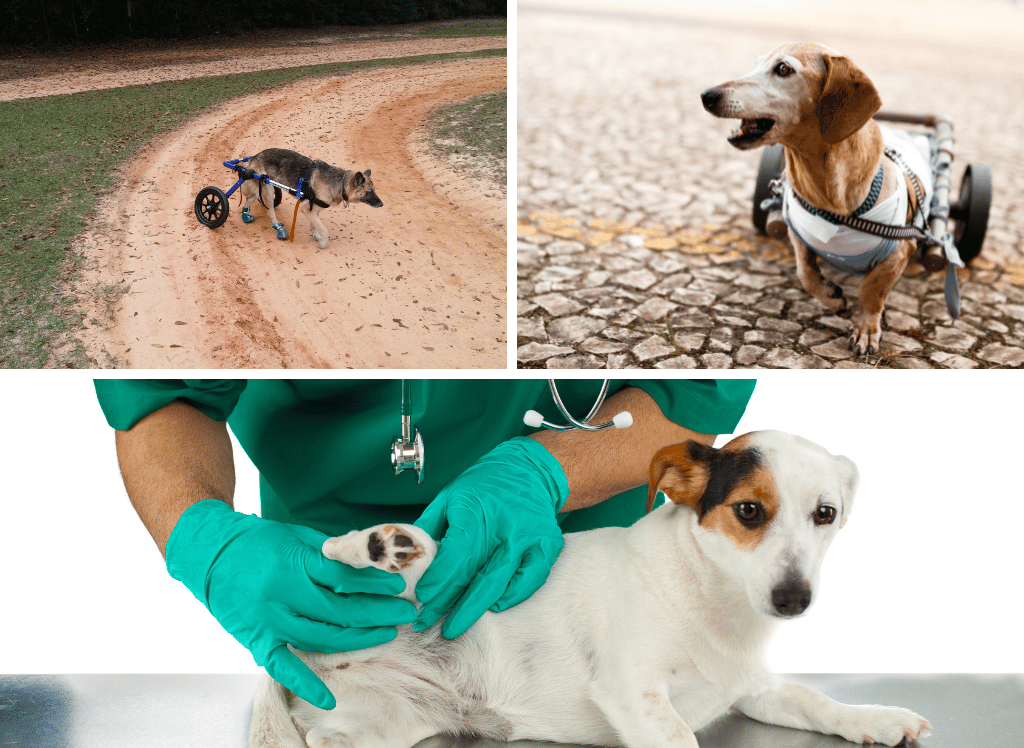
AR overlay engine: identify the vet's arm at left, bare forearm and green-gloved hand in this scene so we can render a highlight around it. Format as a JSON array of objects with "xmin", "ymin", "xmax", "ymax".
[{"xmin": 110, "ymin": 393, "xmax": 416, "ymax": 709}]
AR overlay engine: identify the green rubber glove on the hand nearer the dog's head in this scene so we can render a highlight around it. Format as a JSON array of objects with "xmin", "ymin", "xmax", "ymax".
[{"xmin": 414, "ymin": 437, "xmax": 569, "ymax": 638}]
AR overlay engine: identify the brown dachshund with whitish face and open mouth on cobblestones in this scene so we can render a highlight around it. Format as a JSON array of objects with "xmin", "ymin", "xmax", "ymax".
[{"xmin": 700, "ymin": 43, "xmax": 932, "ymax": 355}]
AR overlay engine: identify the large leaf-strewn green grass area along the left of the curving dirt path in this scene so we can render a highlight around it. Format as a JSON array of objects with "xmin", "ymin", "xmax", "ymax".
[{"xmin": 0, "ymin": 40, "xmax": 506, "ymax": 368}]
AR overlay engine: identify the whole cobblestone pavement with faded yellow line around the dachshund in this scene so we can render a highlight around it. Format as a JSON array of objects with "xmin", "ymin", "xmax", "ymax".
[{"xmin": 517, "ymin": 0, "xmax": 1024, "ymax": 368}]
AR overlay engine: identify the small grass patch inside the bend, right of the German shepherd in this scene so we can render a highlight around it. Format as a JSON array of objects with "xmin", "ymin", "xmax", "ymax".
[{"xmin": 430, "ymin": 90, "xmax": 508, "ymax": 184}]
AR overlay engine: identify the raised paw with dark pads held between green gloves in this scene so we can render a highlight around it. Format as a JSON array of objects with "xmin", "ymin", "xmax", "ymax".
[{"xmin": 324, "ymin": 525, "xmax": 436, "ymax": 573}]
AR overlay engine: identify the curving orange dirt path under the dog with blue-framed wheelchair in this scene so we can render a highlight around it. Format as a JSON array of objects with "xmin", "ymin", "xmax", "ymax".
[{"xmin": 68, "ymin": 58, "xmax": 507, "ymax": 369}]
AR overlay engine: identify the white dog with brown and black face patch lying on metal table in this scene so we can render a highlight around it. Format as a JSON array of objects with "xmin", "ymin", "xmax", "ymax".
[{"xmin": 250, "ymin": 431, "xmax": 931, "ymax": 748}]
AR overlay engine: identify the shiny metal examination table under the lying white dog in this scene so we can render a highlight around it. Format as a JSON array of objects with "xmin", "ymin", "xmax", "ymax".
[{"xmin": 0, "ymin": 675, "xmax": 1024, "ymax": 748}]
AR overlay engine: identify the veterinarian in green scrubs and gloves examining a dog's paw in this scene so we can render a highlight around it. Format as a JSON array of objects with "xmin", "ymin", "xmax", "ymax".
[{"xmin": 95, "ymin": 379, "xmax": 755, "ymax": 709}]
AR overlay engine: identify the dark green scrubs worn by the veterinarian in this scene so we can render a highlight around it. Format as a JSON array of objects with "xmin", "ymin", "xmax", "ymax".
[{"xmin": 95, "ymin": 379, "xmax": 755, "ymax": 535}]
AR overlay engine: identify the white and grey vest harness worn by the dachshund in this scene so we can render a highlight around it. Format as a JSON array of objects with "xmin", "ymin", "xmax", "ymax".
[{"xmin": 774, "ymin": 125, "xmax": 963, "ymax": 319}]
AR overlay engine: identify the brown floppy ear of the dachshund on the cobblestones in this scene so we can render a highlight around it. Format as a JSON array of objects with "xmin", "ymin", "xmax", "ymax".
[{"xmin": 817, "ymin": 53, "xmax": 882, "ymax": 146}]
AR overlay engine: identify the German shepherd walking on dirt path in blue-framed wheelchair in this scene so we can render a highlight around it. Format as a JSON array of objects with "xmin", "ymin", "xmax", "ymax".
[{"xmin": 241, "ymin": 148, "xmax": 384, "ymax": 249}]
